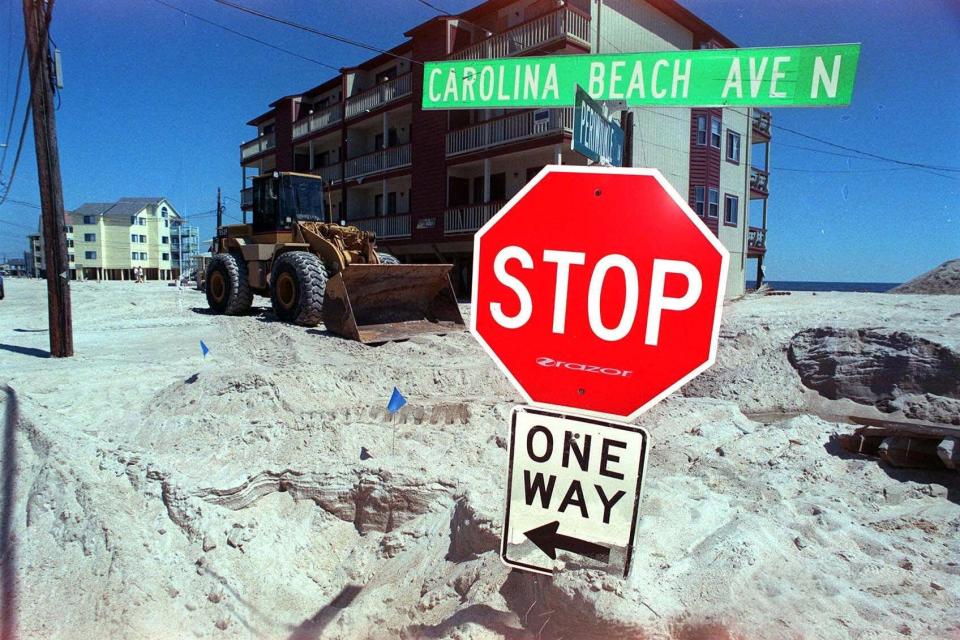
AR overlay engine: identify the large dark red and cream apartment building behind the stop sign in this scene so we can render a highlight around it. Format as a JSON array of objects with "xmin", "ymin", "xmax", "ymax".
[{"xmin": 240, "ymin": 0, "xmax": 770, "ymax": 296}]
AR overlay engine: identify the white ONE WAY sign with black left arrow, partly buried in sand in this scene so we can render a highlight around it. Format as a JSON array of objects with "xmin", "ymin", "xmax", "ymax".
[{"xmin": 500, "ymin": 407, "xmax": 648, "ymax": 577}]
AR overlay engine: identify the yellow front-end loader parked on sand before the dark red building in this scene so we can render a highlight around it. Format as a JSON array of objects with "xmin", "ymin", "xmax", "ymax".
[{"xmin": 206, "ymin": 172, "xmax": 464, "ymax": 344}]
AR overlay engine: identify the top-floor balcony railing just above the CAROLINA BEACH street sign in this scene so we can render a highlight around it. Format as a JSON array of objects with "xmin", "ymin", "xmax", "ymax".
[{"xmin": 450, "ymin": 7, "xmax": 590, "ymax": 60}]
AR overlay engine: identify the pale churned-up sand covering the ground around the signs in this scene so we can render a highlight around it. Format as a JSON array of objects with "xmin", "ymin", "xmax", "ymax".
[{"xmin": 0, "ymin": 279, "xmax": 960, "ymax": 639}]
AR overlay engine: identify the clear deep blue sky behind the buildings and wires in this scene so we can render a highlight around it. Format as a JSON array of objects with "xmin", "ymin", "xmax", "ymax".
[{"xmin": 0, "ymin": 0, "xmax": 960, "ymax": 282}]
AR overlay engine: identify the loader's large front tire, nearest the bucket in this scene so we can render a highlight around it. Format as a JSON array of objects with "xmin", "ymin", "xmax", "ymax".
[{"xmin": 270, "ymin": 251, "xmax": 327, "ymax": 327}]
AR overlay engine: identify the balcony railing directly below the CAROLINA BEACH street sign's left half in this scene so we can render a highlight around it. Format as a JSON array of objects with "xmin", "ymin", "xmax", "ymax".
[{"xmin": 447, "ymin": 109, "xmax": 573, "ymax": 156}]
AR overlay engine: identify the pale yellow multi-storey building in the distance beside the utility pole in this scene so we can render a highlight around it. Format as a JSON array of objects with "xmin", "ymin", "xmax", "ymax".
[{"xmin": 28, "ymin": 197, "xmax": 183, "ymax": 280}]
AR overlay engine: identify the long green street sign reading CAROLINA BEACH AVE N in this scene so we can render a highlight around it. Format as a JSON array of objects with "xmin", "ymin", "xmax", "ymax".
[{"xmin": 423, "ymin": 44, "xmax": 860, "ymax": 109}]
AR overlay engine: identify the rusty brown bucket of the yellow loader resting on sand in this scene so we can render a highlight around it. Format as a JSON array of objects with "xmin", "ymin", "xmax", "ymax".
[{"xmin": 323, "ymin": 264, "xmax": 465, "ymax": 344}]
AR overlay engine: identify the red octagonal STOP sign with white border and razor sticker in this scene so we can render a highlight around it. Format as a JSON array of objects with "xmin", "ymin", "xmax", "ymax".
[{"xmin": 470, "ymin": 166, "xmax": 729, "ymax": 419}]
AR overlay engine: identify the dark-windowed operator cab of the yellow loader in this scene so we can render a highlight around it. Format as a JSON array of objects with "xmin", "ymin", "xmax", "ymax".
[{"xmin": 253, "ymin": 172, "xmax": 327, "ymax": 233}]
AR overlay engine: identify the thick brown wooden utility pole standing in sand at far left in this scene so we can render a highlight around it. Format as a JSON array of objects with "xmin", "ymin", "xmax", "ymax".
[{"xmin": 23, "ymin": 0, "xmax": 73, "ymax": 358}]
